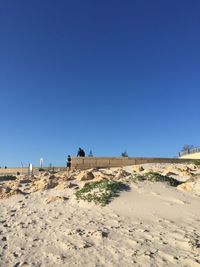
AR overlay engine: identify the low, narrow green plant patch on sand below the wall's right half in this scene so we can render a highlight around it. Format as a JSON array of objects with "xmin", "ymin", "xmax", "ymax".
[{"xmin": 133, "ymin": 172, "xmax": 182, "ymax": 186}]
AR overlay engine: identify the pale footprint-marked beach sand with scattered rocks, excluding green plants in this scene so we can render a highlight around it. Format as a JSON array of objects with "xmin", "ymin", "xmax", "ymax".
[{"xmin": 0, "ymin": 164, "xmax": 200, "ymax": 267}]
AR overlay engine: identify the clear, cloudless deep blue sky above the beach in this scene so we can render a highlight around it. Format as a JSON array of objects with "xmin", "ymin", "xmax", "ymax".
[{"xmin": 0, "ymin": 0, "xmax": 200, "ymax": 166}]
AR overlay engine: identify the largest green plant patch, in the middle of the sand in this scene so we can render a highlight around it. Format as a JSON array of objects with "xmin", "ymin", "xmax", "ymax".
[{"xmin": 75, "ymin": 179, "xmax": 129, "ymax": 206}]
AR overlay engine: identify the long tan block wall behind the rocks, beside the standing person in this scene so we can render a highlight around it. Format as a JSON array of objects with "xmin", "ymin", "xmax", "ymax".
[{"xmin": 72, "ymin": 157, "xmax": 196, "ymax": 169}]
